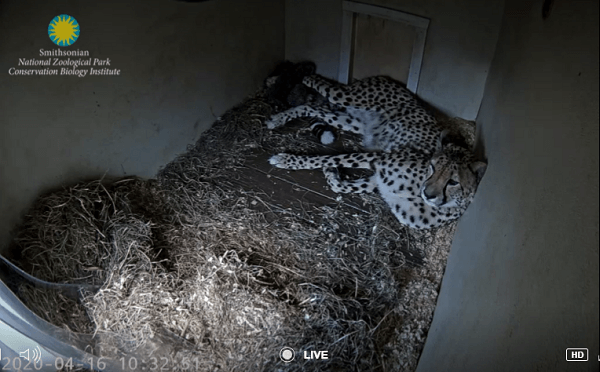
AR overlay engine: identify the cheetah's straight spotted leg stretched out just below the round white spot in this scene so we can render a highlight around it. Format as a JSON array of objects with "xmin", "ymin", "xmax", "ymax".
[{"xmin": 269, "ymin": 152, "xmax": 380, "ymax": 169}]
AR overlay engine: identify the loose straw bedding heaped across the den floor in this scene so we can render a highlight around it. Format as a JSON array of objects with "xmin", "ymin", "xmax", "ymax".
[{"xmin": 5, "ymin": 85, "xmax": 464, "ymax": 371}]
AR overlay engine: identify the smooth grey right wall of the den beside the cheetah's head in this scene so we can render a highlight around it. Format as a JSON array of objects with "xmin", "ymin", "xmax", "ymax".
[{"xmin": 418, "ymin": 0, "xmax": 599, "ymax": 372}]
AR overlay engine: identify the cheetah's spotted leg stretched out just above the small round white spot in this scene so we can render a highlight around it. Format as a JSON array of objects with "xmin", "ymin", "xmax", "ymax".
[{"xmin": 265, "ymin": 105, "xmax": 364, "ymax": 134}]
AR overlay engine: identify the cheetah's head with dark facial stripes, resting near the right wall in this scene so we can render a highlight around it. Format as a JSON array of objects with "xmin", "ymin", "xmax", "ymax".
[{"xmin": 421, "ymin": 131, "xmax": 487, "ymax": 209}]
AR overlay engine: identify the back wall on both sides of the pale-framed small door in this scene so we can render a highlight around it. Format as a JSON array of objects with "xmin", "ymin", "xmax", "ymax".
[{"xmin": 285, "ymin": 0, "xmax": 504, "ymax": 120}]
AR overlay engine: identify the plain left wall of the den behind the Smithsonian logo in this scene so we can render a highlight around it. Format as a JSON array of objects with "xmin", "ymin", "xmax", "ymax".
[{"xmin": 0, "ymin": 0, "xmax": 284, "ymax": 253}]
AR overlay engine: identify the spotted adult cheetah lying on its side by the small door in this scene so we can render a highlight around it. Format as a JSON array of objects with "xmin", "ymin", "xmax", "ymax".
[{"xmin": 266, "ymin": 75, "xmax": 487, "ymax": 229}]
